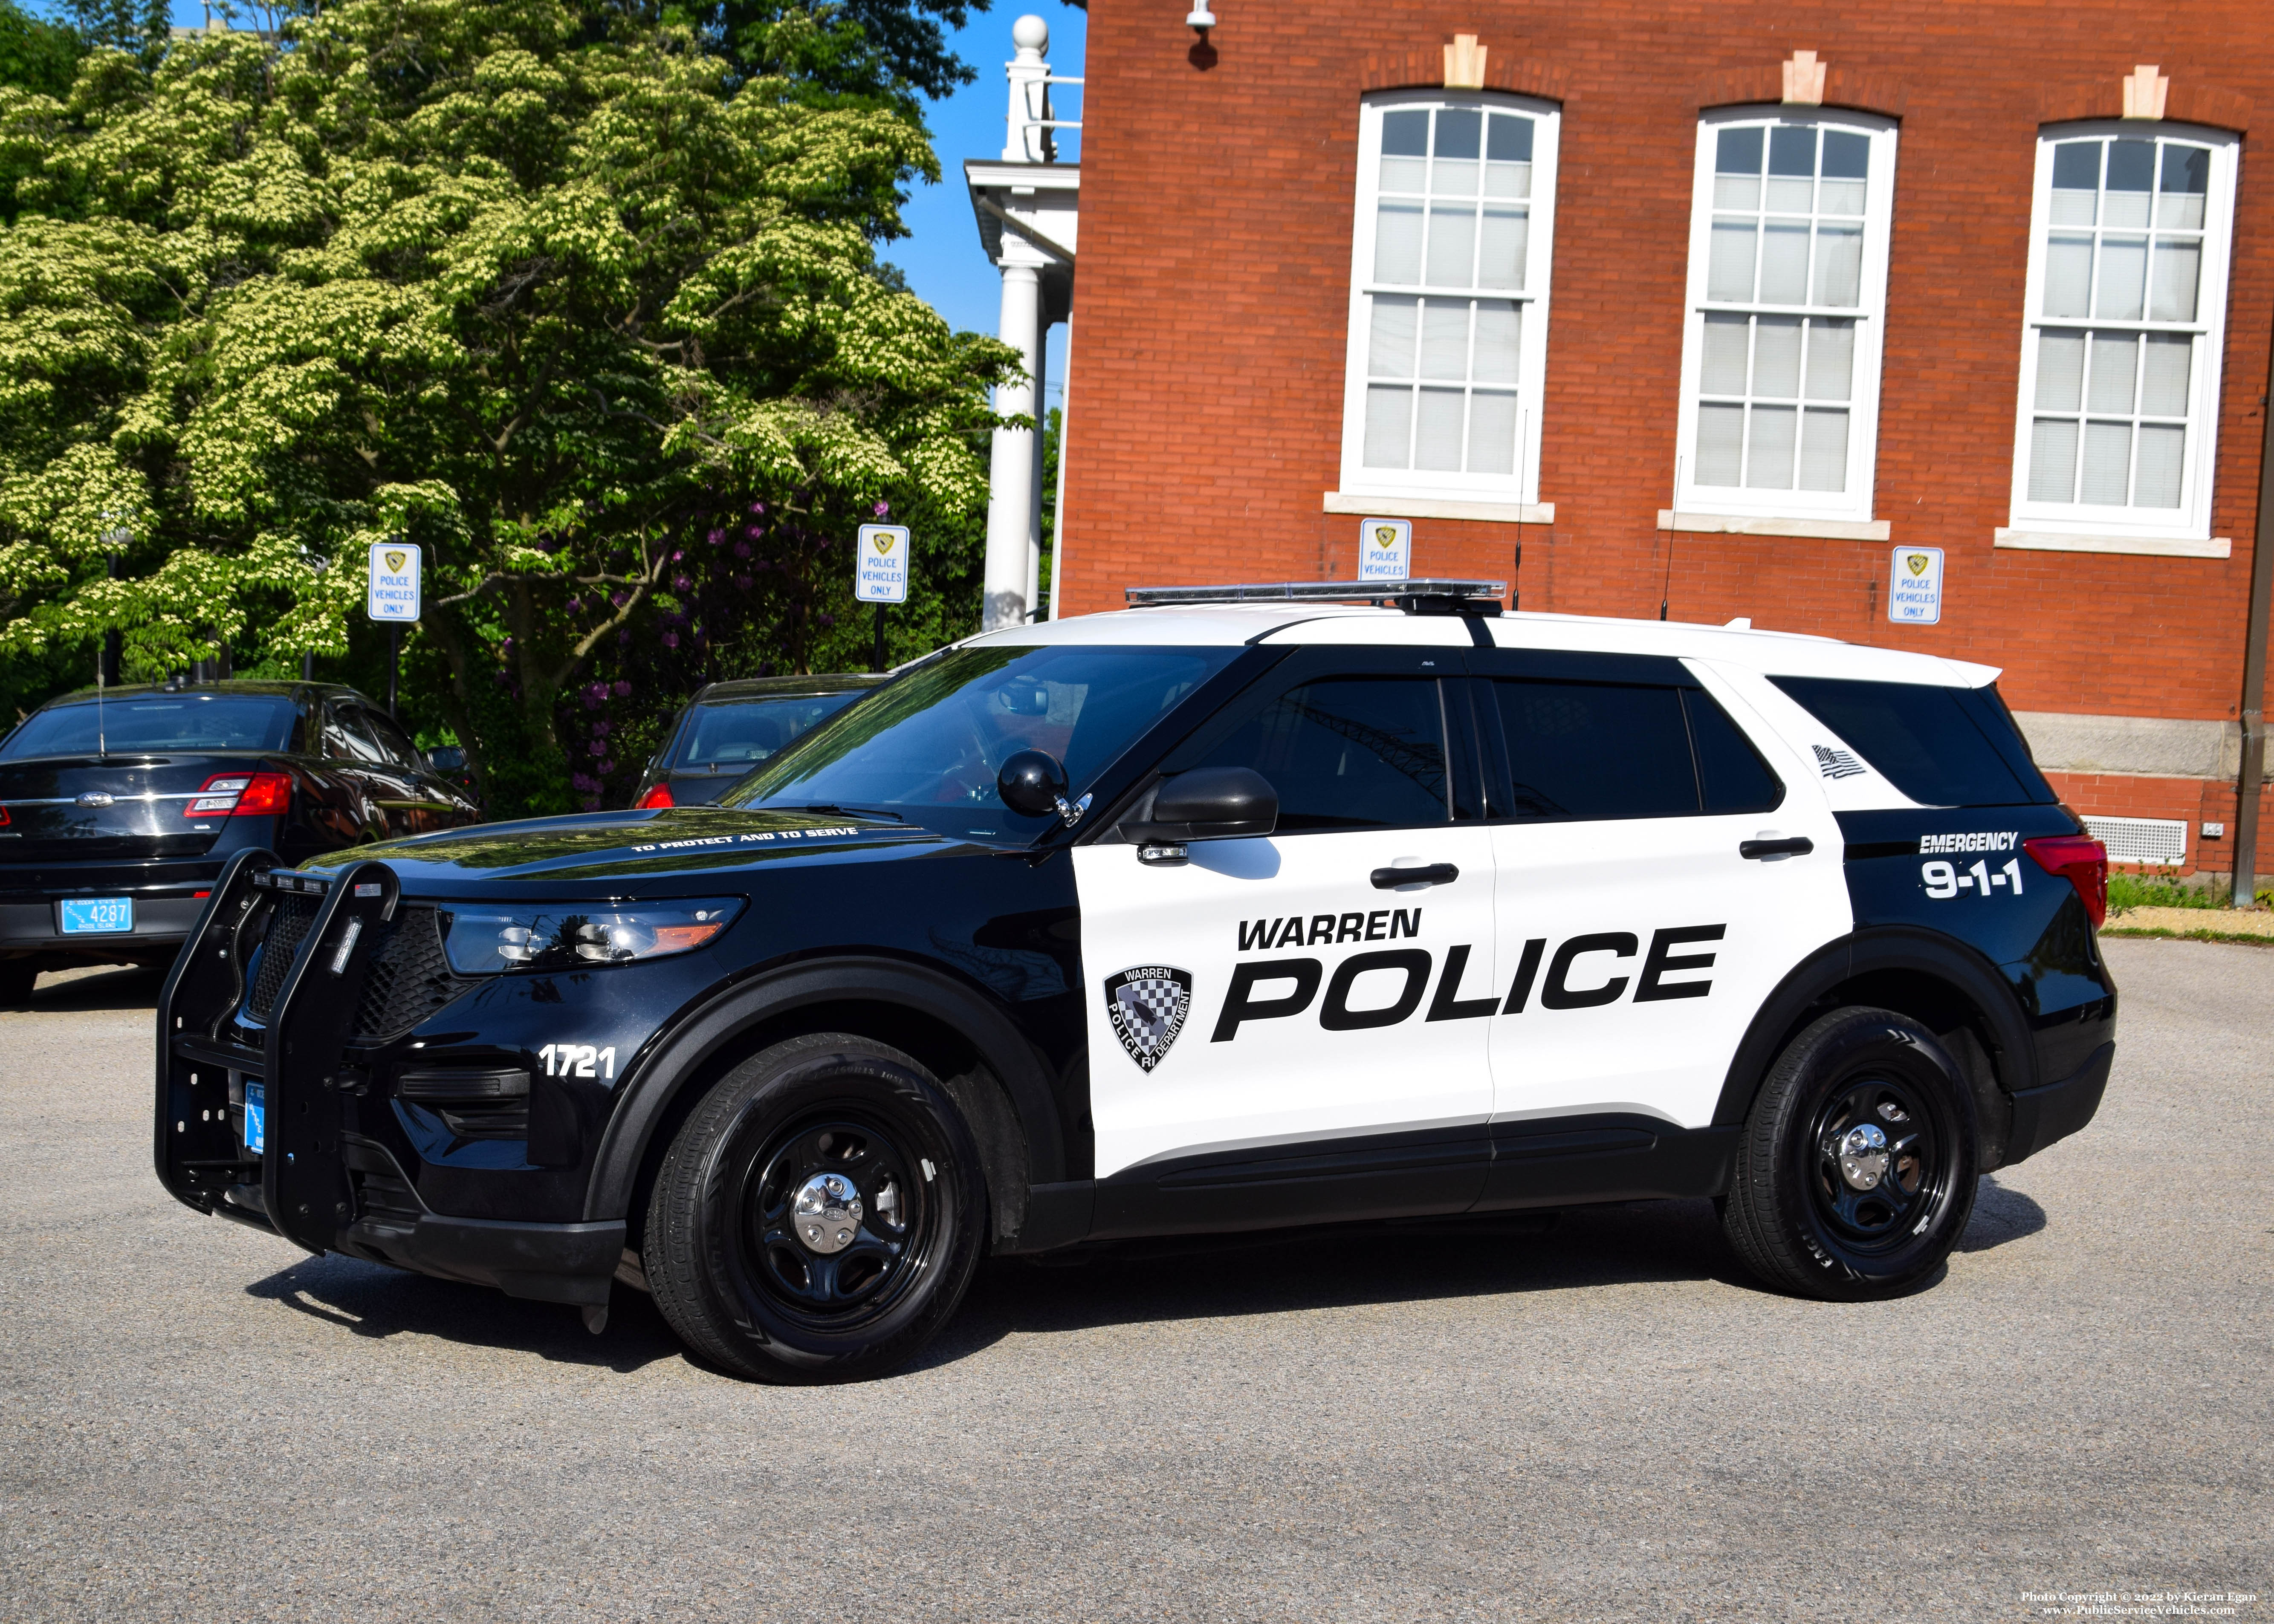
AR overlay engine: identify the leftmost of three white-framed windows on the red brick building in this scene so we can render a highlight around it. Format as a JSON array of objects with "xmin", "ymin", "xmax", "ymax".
[{"xmin": 1342, "ymin": 91, "xmax": 1558, "ymax": 503}]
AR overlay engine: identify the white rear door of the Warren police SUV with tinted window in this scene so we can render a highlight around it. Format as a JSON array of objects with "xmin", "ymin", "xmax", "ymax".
[{"xmin": 1473, "ymin": 650, "xmax": 1853, "ymax": 1128}]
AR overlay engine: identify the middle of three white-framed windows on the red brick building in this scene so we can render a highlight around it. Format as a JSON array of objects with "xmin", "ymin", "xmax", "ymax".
[{"xmin": 1674, "ymin": 107, "xmax": 1894, "ymax": 521}]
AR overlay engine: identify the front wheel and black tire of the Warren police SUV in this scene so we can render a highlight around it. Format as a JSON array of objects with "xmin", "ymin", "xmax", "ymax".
[{"xmin": 641, "ymin": 1033, "xmax": 987, "ymax": 1383}]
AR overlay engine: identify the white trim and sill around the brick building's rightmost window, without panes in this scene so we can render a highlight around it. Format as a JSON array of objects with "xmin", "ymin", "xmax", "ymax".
[{"xmin": 1996, "ymin": 118, "xmax": 2242, "ymax": 543}]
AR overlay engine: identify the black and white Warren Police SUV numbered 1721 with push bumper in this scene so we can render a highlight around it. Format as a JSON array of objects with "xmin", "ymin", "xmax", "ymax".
[{"xmin": 155, "ymin": 580, "xmax": 2115, "ymax": 1381}]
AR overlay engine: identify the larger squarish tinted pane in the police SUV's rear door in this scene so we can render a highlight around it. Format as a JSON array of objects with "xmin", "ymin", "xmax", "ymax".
[{"xmin": 1492, "ymin": 678, "xmax": 1698, "ymax": 819}]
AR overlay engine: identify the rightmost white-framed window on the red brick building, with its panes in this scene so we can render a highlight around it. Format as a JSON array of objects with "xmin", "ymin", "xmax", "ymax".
[{"xmin": 2013, "ymin": 121, "xmax": 2235, "ymax": 539}]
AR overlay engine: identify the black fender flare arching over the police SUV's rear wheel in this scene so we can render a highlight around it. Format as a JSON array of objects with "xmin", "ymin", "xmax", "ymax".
[{"xmin": 1713, "ymin": 926, "xmax": 2037, "ymax": 1133}]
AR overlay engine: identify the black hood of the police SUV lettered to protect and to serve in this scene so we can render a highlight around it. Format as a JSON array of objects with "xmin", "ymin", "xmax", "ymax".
[{"xmin": 302, "ymin": 807, "xmax": 941, "ymax": 896}]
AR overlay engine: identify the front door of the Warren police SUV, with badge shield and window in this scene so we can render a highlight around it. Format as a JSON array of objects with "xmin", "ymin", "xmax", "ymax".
[{"xmin": 1076, "ymin": 650, "xmax": 1499, "ymax": 1233}]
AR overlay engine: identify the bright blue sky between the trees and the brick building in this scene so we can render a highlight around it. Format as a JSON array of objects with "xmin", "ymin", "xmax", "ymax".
[{"xmin": 156, "ymin": 0, "xmax": 1089, "ymax": 405}]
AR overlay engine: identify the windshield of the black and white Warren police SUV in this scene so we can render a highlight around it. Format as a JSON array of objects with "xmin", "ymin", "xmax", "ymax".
[{"xmin": 726, "ymin": 644, "xmax": 1239, "ymax": 839}]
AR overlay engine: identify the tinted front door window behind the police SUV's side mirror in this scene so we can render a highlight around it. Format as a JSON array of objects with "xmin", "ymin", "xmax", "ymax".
[{"xmin": 1194, "ymin": 676, "xmax": 1449, "ymax": 835}]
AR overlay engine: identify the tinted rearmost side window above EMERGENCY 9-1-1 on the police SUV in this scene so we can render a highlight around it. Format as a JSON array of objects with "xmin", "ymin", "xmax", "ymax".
[{"xmin": 1771, "ymin": 678, "xmax": 2056, "ymax": 807}]
